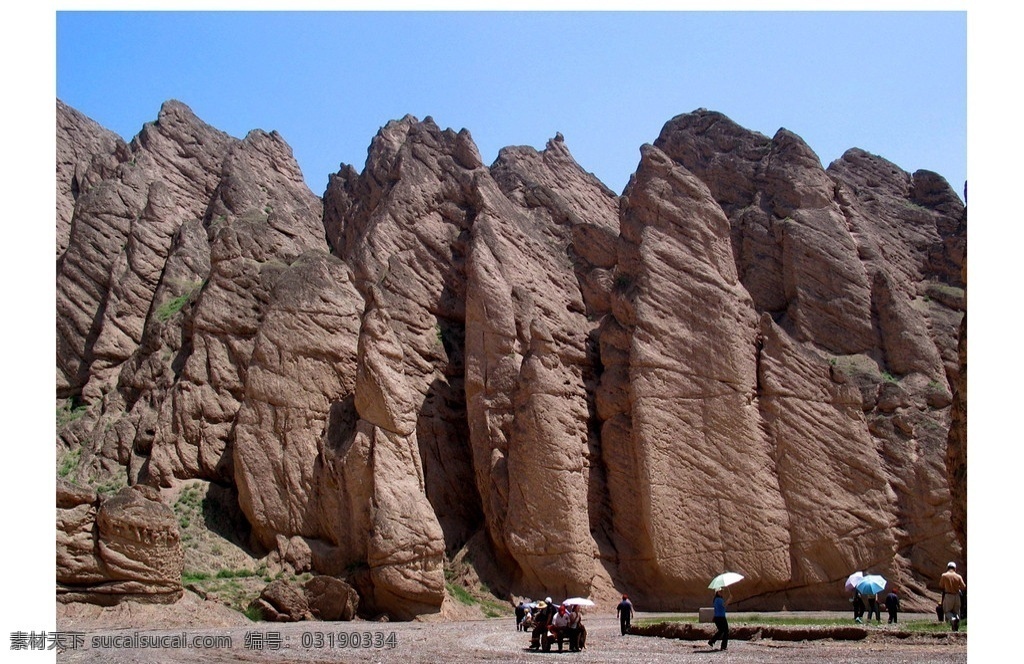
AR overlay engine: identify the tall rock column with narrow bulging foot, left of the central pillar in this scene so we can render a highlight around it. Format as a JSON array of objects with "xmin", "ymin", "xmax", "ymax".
[{"xmin": 325, "ymin": 117, "xmax": 480, "ymax": 618}]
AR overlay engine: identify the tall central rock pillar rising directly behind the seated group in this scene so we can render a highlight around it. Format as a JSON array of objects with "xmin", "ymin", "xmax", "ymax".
[{"xmin": 466, "ymin": 135, "xmax": 616, "ymax": 595}]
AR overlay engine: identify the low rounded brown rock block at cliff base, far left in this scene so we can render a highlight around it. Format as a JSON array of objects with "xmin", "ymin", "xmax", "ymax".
[{"xmin": 56, "ymin": 479, "xmax": 184, "ymax": 606}]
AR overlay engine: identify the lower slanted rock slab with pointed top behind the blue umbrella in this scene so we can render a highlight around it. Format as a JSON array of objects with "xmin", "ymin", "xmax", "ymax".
[{"xmin": 758, "ymin": 315, "xmax": 897, "ymax": 604}]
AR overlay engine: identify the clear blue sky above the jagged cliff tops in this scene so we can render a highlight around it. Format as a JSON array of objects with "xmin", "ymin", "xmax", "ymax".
[{"xmin": 56, "ymin": 11, "xmax": 967, "ymax": 194}]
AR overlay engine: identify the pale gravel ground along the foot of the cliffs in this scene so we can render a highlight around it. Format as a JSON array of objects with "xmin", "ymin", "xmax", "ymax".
[{"xmin": 57, "ymin": 613, "xmax": 967, "ymax": 664}]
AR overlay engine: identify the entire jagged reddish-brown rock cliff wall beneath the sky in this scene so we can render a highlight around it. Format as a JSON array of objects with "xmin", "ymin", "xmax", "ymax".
[{"xmin": 56, "ymin": 101, "xmax": 967, "ymax": 619}]
